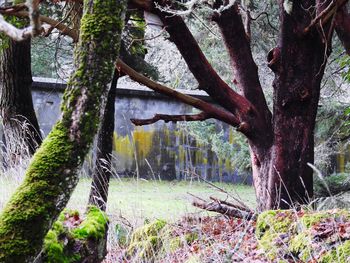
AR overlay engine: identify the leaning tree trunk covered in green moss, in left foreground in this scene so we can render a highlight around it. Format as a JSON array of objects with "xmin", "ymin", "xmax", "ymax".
[{"xmin": 0, "ymin": 0, "xmax": 125, "ymax": 262}]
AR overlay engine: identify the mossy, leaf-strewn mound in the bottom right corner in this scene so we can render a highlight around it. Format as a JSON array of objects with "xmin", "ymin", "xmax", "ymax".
[{"xmin": 255, "ymin": 210, "xmax": 350, "ymax": 263}]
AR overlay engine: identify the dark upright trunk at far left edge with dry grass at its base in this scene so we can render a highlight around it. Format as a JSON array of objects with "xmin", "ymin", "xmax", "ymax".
[{"xmin": 0, "ymin": 37, "xmax": 41, "ymax": 161}]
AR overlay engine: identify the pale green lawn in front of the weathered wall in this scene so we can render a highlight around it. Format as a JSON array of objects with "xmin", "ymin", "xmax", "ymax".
[{"xmin": 0, "ymin": 179, "xmax": 255, "ymax": 228}]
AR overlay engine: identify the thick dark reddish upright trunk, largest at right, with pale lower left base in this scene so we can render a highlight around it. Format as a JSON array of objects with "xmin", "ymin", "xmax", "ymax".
[{"xmin": 252, "ymin": 0, "xmax": 331, "ymax": 210}]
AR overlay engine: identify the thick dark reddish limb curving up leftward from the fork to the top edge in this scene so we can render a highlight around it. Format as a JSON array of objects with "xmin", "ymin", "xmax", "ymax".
[{"xmin": 132, "ymin": 0, "xmax": 271, "ymax": 145}]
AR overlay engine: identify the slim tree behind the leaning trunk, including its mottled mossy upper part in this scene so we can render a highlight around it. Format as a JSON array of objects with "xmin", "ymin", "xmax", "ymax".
[{"xmin": 88, "ymin": 10, "xmax": 158, "ymax": 211}]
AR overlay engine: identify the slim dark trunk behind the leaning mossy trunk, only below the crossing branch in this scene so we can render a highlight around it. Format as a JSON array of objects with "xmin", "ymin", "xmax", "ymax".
[{"xmin": 89, "ymin": 71, "xmax": 119, "ymax": 211}]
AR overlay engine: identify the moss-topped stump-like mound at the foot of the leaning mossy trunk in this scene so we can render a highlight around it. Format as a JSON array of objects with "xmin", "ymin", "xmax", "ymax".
[{"xmin": 42, "ymin": 206, "xmax": 108, "ymax": 263}]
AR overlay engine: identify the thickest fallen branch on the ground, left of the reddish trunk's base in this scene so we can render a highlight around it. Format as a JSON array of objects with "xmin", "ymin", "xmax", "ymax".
[{"xmin": 192, "ymin": 200, "xmax": 256, "ymax": 220}]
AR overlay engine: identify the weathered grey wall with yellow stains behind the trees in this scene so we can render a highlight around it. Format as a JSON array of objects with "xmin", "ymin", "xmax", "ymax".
[{"xmin": 32, "ymin": 79, "xmax": 251, "ymax": 184}]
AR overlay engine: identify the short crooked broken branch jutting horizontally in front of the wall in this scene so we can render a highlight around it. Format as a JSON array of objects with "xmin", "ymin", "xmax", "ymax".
[{"xmin": 130, "ymin": 112, "xmax": 211, "ymax": 126}]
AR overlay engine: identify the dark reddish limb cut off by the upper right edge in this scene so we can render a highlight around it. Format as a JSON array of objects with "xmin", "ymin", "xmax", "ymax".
[{"xmin": 335, "ymin": 3, "xmax": 350, "ymax": 55}]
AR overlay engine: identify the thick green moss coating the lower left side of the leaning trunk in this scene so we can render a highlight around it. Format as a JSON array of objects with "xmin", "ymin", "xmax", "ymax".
[{"xmin": 0, "ymin": 123, "xmax": 74, "ymax": 262}]
